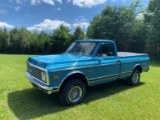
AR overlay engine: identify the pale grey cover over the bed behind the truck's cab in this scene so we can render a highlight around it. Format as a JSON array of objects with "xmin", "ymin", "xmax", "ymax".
[{"xmin": 117, "ymin": 52, "xmax": 147, "ymax": 57}]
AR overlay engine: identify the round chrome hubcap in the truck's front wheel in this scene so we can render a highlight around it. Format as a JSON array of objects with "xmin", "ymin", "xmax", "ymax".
[{"xmin": 68, "ymin": 86, "xmax": 82, "ymax": 102}]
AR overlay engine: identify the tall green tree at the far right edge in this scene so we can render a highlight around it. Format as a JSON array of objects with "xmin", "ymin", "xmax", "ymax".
[{"xmin": 145, "ymin": 0, "xmax": 160, "ymax": 59}]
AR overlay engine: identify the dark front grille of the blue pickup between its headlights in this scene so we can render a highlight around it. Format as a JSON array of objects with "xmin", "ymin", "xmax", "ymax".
[{"xmin": 27, "ymin": 63, "xmax": 44, "ymax": 82}]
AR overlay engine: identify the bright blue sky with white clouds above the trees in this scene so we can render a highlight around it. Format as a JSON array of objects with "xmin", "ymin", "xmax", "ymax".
[{"xmin": 0, "ymin": 0, "xmax": 149, "ymax": 31}]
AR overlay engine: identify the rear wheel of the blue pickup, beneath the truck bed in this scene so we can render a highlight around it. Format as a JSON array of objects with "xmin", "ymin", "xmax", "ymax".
[{"xmin": 127, "ymin": 69, "xmax": 140, "ymax": 86}]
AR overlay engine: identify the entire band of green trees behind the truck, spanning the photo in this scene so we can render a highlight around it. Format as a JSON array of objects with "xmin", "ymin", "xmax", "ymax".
[{"xmin": 0, "ymin": 0, "xmax": 160, "ymax": 59}]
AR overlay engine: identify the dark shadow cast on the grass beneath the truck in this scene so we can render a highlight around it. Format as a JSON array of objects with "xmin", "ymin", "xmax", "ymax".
[{"xmin": 8, "ymin": 81, "xmax": 144, "ymax": 119}]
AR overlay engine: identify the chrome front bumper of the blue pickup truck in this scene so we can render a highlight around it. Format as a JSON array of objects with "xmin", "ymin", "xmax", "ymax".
[{"xmin": 26, "ymin": 72, "xmax": 58, "ymax": 94}]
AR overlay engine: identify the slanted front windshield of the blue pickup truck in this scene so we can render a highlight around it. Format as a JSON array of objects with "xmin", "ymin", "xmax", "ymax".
[{"xmin": 66, "ymin": 42, "xmax": 97, "ymax": 55}]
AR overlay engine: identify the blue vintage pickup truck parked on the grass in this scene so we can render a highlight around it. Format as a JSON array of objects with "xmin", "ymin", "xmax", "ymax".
[{"xmin": 26, "ymin": 40, "xmax": 150, "ymax": 105}]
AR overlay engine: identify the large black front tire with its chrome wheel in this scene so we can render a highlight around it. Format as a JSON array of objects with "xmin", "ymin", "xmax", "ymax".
[{"xmin": 59, "ymin": 79, "xmax": 86, "ymax": 105}]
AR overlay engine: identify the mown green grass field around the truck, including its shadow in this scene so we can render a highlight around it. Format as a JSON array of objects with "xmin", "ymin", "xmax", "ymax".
[{"xmin": 0, "ymin": 55, "xmax": 160, "ymax": 120}]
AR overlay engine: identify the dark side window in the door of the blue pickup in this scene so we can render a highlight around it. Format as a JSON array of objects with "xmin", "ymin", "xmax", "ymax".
[{"xmin": 97, "ymin": 43, "xmax": 115, "ymax": 56}]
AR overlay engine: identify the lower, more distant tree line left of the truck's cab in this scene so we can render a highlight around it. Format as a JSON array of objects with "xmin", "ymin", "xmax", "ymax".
[{"xmin": 0, "ymin": 25, "xmax": 85, "ymax": 54}]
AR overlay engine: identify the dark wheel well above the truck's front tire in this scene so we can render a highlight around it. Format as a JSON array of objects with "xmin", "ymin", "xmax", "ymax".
[{"xmin": 62, "ymin": 73, "xmax": 88, "ymax": 86}]
